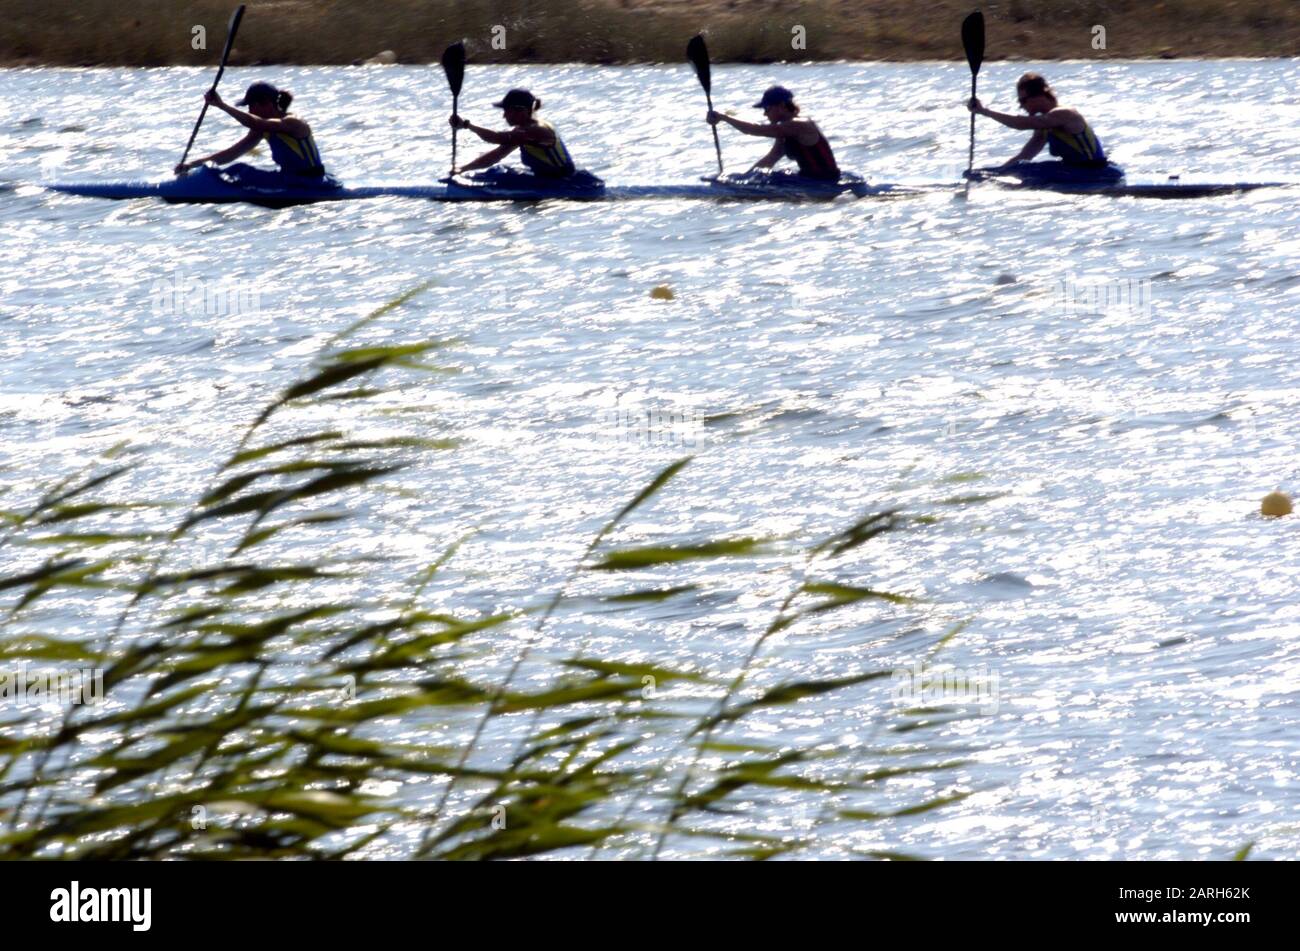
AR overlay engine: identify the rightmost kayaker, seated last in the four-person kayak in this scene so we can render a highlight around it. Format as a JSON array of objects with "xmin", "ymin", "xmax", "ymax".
[{"xmin": 966, "ymin": 73, "xmax": 1125, "ymax": 182}]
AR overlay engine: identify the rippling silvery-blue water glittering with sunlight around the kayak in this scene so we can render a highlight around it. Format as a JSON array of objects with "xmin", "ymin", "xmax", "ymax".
[{"xmin": 0, "ymin": 60, "xmax": 1300, "ymax": 859}]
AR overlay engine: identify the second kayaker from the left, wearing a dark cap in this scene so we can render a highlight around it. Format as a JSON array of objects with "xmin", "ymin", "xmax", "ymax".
[{"xmin": 451, "ymin": 90, "xmax": 594, "ymax": 186}]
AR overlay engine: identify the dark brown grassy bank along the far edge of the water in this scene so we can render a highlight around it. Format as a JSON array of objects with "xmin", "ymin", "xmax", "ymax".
[{"xmin": 0, "ymin": 0, "xmax": 1300, "ymax": 66}]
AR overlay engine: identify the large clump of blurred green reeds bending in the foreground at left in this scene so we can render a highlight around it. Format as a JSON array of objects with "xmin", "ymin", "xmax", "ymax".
[{"xmin": 0, "ymin": 281, "xmax": 979, "ymax": 859}]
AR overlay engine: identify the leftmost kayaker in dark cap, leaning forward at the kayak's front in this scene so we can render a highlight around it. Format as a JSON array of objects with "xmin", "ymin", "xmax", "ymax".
[{"xmin": 176, "ymin": 82, "xmax": 333, "ymax": 188}]
